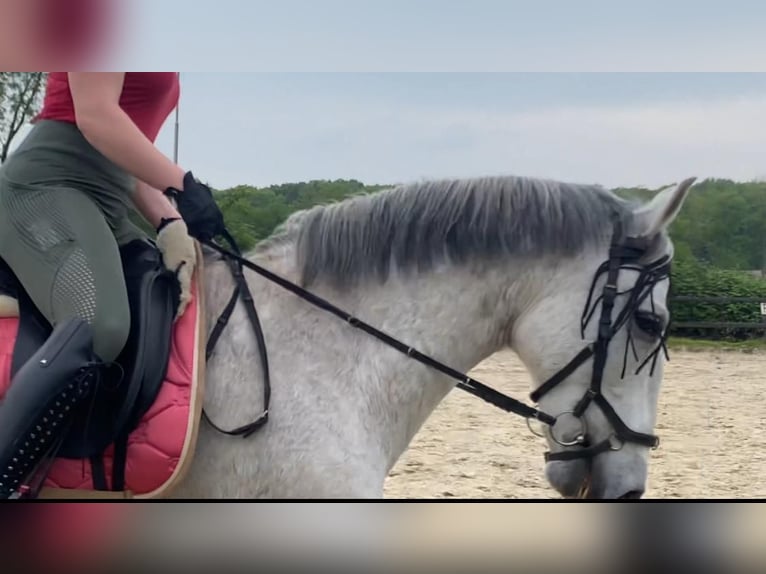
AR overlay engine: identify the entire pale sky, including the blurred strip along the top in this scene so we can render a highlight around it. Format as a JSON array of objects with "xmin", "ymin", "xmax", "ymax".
[{"xmin": 10, "ymin": 0, "xmax": 766, "ymax": 189}]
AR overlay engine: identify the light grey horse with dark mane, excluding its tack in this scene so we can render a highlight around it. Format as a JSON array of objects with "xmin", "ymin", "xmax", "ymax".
[{"xmin": 174, "ymin": 177, "xmax": 694, "ymax": 498}]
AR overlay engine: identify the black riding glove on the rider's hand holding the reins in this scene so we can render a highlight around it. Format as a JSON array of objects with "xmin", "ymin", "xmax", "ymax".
[{"xmin": 165, "ymin": 172, "xmax": 226, "ymax": 241}]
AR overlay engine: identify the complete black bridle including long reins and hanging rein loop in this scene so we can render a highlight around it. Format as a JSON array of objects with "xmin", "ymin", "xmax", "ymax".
[{"xmin": 201, "ymin": 214, "xmax": 670, "ymax": 461}]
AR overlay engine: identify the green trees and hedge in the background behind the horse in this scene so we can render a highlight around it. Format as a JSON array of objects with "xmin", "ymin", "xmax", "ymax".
[{"xmin": 210, "ymin": 180, "xmax": 766, "ymax": 340}]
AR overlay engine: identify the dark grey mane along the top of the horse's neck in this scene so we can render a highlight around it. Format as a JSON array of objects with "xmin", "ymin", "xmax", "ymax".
[{"xmin": 258, "ymin": 176, "xmax": 631, "ymax": 287}]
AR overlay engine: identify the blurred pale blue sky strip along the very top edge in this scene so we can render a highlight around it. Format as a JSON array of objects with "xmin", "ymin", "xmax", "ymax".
[{"xmin": 114, "ymin": 0, "xmax": 766, "ymax": 72}]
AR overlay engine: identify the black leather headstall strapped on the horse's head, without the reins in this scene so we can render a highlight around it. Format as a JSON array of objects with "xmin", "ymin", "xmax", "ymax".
[{"xmin": 527, "ymin": 216, "xmax": 670, "ymax": 461}]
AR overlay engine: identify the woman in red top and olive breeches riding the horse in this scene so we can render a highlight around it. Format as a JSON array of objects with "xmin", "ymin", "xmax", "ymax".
[{"xmin": 0, "ymin": 72, "xmax": 223, "ymax": 498}]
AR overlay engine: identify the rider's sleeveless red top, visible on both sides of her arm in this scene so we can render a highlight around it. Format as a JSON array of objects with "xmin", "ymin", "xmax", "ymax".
[{"xmin": 37, "ymin": 72, "xmax": 181, "ymax": 142}]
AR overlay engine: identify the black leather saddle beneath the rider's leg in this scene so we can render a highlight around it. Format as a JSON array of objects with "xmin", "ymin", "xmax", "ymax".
[{"xmin": 0, "ymin": 240, "xmax": 179, "ymax": 491}]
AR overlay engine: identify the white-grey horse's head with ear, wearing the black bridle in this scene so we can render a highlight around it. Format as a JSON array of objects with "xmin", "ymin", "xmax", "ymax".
[{"xmin": 513, "ymin": 179, "xmax": 694, "ymax": 498}]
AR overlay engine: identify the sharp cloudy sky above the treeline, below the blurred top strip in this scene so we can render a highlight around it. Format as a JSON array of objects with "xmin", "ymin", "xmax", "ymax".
[{"xmin": 148, "ymin": 72, "xmax": 766, "ymax": 188}]
